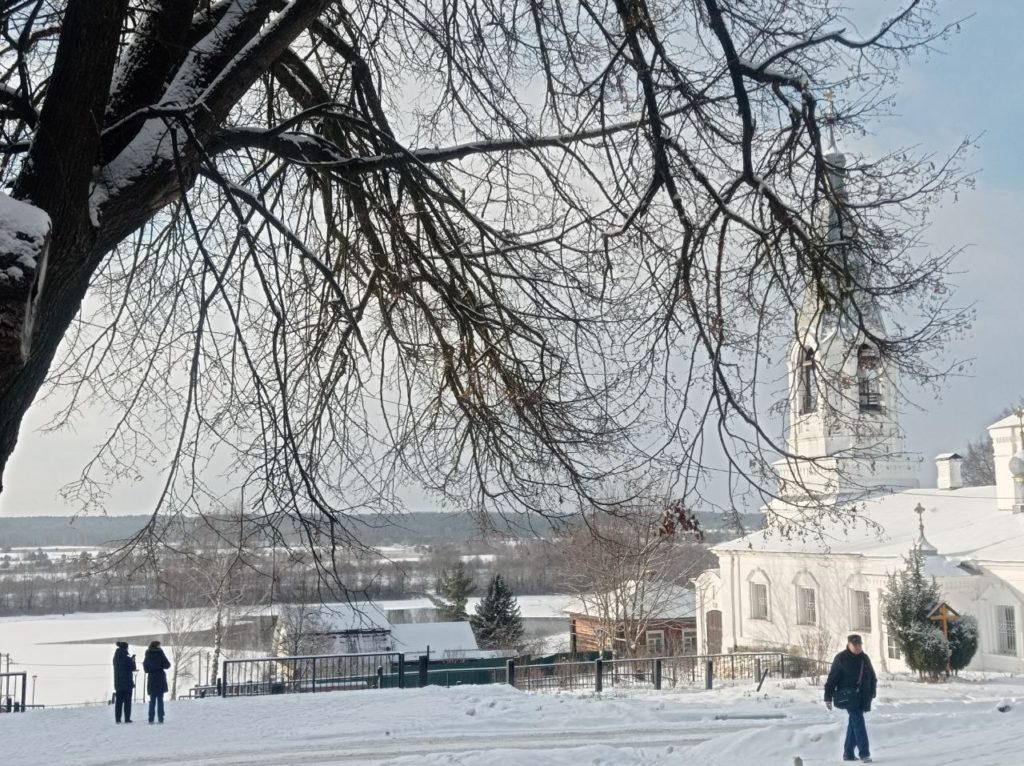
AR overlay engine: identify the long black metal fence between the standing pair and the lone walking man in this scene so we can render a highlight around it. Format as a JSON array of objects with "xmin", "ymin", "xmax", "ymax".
[{"xmin": 217, "ymin": 652, "xmax": 828, "ymax": 696}]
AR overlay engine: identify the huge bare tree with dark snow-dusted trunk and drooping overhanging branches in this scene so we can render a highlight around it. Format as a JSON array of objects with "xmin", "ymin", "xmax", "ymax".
[{"xmin": 0, "ymin": 0, "xmax": 962, "ymax": 580}]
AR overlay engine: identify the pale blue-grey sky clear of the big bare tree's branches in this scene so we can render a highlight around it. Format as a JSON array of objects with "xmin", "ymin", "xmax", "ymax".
[{"xmin": 0, "ymin": 0, "xmax": 1024, "ymax": 516}]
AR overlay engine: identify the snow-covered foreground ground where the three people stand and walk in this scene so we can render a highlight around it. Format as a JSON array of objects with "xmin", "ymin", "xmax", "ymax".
[{"xmin": 0, "ymin": 678, "xmax": 1024, "ymax": 766}]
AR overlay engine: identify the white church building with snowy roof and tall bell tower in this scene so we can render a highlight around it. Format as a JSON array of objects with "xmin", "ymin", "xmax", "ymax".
[{"xmin": 693, "ymin": 142, "xmax": 1024, "ymax": 672}]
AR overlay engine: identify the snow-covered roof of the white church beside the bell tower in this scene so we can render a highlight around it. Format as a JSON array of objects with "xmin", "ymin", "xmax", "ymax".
[{"xmin": 713, "ymin": 486, "xmax": 1024, "ymax": 565}]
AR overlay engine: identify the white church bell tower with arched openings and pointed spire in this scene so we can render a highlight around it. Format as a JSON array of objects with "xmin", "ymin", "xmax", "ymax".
[{"xmin": 772, "ymin": 131, "xmax": 920, "ymax": 511}]
